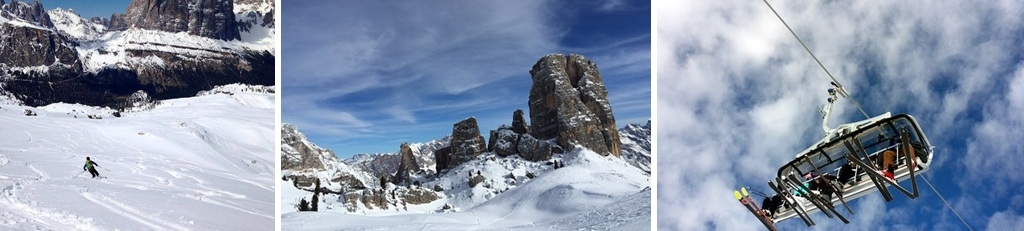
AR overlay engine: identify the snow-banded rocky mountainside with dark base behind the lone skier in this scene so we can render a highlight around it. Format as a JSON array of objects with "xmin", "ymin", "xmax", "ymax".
[{"xmin": 0, "ymin": 0, "xmax": 275, "ymax": 109}]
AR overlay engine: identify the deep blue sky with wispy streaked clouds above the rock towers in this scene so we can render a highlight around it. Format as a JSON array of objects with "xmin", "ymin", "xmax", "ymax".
[{"xmin": 282, "ymin": 0, "xmax": 651, "ymax": 157}]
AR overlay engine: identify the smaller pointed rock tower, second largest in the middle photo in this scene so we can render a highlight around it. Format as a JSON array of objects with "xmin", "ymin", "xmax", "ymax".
[{"xmin": 434, "ymin": 118, "xmax": 486, "ymax": 174}]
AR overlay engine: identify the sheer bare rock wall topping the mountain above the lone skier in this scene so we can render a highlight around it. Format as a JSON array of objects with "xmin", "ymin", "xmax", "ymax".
[{"xmin": 125, "ymin": 0, "xmax": 240, "ymax": 40}]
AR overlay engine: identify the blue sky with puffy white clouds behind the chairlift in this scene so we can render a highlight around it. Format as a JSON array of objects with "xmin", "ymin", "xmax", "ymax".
[{"xmin": 655, "ymin": 0, "xmax": 1024, "ymax": 230}]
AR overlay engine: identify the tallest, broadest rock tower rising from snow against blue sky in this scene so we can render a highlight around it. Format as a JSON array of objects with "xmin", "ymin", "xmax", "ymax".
[{"xmin": 529, "ymin": 54, "xmax": 622, "ymax": 156}]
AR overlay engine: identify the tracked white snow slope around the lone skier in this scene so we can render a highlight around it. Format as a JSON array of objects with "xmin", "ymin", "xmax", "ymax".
[{"xmin": 0, "ymin": 87, "xmax": 275, "ymax": 230}]
